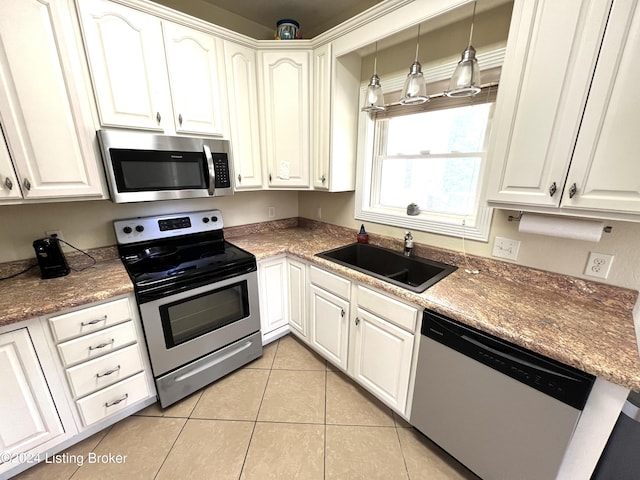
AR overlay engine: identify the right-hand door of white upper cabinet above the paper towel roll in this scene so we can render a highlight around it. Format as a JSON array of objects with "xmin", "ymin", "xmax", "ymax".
[{"xmin": 562, "ymin": 0, "xmax": 640, "ymax": 213}]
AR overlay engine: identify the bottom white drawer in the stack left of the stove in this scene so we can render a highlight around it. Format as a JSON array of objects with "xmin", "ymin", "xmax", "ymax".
[{"xmin": 76, "ymin": 372, "xmax": 150, "ymax": 426}]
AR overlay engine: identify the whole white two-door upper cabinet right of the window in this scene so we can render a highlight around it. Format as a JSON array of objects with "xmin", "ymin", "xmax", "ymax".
[{"xmin": 486, "ymin": 0, "xmax": 640, "ymax": 220}]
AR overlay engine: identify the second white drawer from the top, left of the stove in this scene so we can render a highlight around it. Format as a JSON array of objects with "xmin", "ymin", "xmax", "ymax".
[{"xmin": 58, "ymin": 321, "xmax": 137, "ymax": 367}]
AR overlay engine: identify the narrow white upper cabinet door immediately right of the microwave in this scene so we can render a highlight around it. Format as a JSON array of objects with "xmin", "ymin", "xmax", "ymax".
[{"xmin": 224, "ymin": 42, "xmax": 262, "ymax": 190}]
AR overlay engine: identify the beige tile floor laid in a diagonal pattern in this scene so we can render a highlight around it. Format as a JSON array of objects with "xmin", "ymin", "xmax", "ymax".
[{"xmin": 16, "ymin": 336, "xmax": 477, "ymax": 480}]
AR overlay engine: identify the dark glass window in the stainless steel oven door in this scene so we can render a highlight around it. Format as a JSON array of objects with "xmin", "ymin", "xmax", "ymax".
[{"xmin": 160, "ymin": 281, "xmax": 249, "ymax": 348}]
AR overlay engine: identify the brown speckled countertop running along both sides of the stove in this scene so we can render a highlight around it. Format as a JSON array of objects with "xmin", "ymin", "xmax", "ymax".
[{"xmin": 0, "ymin": 219, "xmax": 640, "ymax": 391}]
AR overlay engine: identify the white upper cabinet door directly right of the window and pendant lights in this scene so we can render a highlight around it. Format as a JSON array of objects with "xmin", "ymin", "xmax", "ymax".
[{"xmin": 487, "ymin": 0, "xmax": 611, "ymax": 207}]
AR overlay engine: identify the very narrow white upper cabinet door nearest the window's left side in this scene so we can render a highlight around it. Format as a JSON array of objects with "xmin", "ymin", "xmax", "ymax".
[{"xmin": 312, "ymin": 44, "xmax": 331, "ymax": 190}]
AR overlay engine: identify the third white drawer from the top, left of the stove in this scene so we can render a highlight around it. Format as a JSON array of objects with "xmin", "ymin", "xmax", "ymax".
[{"xmin": 67, "ymin": 344, "xmax": 143, "ymax": 398}]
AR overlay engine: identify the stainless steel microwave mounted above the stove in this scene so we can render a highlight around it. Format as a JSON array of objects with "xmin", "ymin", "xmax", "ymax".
[{"xmin": 98, "ymin": 130, "xmax": 233, "ymax": 203}]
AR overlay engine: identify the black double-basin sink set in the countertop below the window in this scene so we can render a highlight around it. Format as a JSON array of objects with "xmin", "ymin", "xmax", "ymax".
[{"xmin": 317, "ymin": 243, "xmax": 458, "ymax": 293}]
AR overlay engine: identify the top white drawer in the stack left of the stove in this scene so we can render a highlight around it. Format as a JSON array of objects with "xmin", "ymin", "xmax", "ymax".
[{"xmin": 49, "ymin": 298, "xmax": 131, "ymax": 342}]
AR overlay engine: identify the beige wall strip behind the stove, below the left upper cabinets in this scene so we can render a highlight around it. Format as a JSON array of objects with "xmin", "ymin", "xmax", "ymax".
[{"xmin": 0, "ymin": 191, "xmax": 298, "ymax": 263}]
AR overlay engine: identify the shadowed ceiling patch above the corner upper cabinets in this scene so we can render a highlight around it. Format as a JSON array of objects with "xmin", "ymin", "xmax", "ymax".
[{"xmin": 198, "ymin": 0, "xmax": 382, "ymax": 38}]
